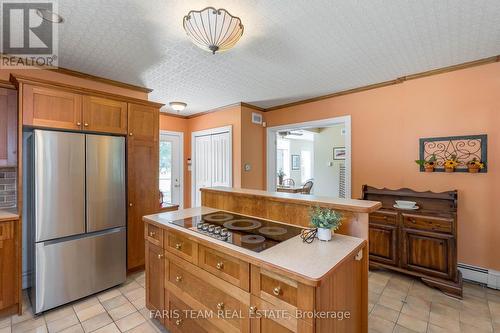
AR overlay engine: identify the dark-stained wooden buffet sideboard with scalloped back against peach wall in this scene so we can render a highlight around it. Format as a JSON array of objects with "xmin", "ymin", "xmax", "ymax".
[{"xmin": 363, "ymin": 185, "xmax": 462, "ymax": 298}]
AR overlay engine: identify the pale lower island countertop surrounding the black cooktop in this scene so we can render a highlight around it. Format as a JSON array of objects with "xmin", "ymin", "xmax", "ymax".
[{"xmin": 144, "ymin": 207, "xmax": 364, "ymax": 281}]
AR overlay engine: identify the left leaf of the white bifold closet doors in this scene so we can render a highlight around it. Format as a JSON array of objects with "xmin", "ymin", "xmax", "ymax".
[{"xmin": 194, "ymin": 135, "xmax": 212, "ymax": 207}]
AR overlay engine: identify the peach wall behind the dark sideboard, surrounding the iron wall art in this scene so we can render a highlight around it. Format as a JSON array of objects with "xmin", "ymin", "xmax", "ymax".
[{"xmin": 264, "ymin": 63, "xmax": 500, "ymax": 270}]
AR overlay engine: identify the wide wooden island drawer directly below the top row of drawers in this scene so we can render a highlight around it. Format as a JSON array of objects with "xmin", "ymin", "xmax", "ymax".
[{"xmin": 165, "ymin": 254, "xmax": 250, "ymax": 332}]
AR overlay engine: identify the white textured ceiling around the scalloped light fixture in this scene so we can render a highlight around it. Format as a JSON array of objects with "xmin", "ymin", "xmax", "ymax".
[{"xmin": 51, "ymin": 0, "xmax": 500, "ymax": 114}]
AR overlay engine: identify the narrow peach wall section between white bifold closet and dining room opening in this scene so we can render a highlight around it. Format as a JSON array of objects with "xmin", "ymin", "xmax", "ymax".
[{"xmin": 241, "ymin": 106, "xmax": 266, "ymax": 190}]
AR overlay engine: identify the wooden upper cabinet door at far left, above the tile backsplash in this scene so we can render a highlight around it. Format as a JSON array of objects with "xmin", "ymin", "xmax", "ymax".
[{"xmin": 0, "ymin": 88, "xmax": 17, "ymax": 166}]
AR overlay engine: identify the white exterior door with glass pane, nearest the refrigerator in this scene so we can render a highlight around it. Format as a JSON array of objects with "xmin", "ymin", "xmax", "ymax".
[{"xmin": 160, "ymin": 132, "xmax": 183, "ymax": 207}]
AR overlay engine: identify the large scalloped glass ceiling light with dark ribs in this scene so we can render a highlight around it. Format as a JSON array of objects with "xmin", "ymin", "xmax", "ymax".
[{"xmin": 183, "ymin": 7, "xmax": 243, "ymax": 54}]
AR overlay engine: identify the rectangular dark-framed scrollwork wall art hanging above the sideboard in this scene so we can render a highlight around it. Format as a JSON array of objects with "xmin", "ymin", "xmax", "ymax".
[{"xmin": 420, "ymin": 134, "xmax": 488, "ymax": 173}]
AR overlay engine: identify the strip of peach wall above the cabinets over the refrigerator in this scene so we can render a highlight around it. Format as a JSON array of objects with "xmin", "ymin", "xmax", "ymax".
[{"xmin": 0, "ymin": 69, "xmax": 148, "ymax": 100}]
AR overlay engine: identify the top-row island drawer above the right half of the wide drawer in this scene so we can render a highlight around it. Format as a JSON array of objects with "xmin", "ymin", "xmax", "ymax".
[{"xmin": 198, "ymin": 245, "xmax": 250, "ymax": 291}]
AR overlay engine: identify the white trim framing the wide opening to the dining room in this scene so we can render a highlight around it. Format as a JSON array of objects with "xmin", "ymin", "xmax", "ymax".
[{"xmin": 266, "ymin": 115, "xmax": 352, "ymax": 199}]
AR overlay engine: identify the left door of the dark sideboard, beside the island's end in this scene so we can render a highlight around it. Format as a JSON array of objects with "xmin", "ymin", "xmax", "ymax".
[{"xmin": 369, "ymin": 223, "xmax": 398, "ymax": 265}]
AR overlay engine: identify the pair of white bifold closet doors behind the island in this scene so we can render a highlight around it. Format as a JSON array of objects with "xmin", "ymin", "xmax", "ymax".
[{"xmin": 192, "ymin": 126, "xmax": 233, "ymax": 207}]
